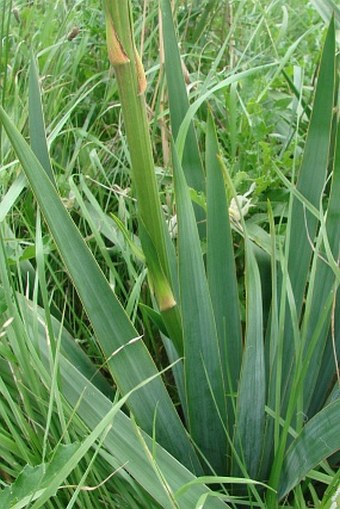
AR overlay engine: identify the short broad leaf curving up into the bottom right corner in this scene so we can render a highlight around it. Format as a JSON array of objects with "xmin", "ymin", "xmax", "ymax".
[{"xmin": 279, "ymin": 399, "xmax": 340, "ymax": 498}]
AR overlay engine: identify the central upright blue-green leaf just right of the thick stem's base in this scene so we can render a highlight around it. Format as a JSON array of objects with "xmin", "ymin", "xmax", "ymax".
[{"xmin": 173, "ymin": 143, "xmax": 226, "ymax": 473}]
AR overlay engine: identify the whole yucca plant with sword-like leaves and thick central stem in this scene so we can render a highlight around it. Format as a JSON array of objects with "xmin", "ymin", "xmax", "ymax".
[{"xmin": 0, "ymin": 0, "xmax": 340, "ymax": 509}]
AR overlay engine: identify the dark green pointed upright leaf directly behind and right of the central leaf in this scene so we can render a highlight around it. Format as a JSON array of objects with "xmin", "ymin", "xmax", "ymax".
[{"xmin": 206, "ymin": 114, "xmax": 242, "ymax": 435}]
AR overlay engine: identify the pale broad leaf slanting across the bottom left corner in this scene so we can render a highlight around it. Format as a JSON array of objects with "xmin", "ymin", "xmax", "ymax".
[{"xmin": 21, "ymin": 298, "xmax": 224, "ymax": 509}]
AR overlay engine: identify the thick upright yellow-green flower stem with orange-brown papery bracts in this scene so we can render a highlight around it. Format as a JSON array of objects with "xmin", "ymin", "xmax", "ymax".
[{"xmin": 104, "ymin": 0, "xmax": 183, "ymax": 355}]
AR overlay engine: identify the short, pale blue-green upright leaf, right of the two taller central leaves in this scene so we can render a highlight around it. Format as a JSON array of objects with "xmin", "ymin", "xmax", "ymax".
[{"xmin": 235, "ymin": 239, "xmax": 266, "ymax": 479}]
